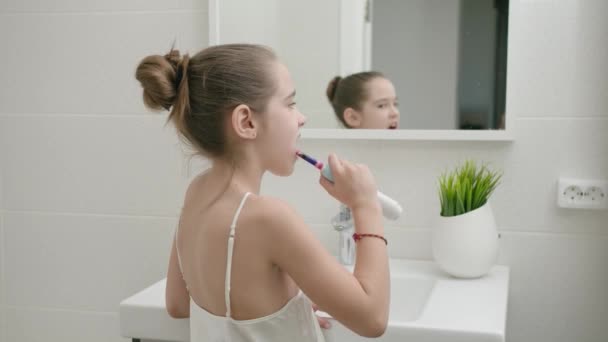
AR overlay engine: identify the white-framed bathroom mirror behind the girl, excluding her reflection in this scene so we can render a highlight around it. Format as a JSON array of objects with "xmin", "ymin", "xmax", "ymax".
[{"xmin": 209, "ymin": 0, "xmax": 513, "ymax": 140}]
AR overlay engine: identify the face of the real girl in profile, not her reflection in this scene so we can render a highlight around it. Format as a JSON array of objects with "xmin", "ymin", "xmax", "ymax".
[{"xmin": 259, "ymin": 62, "xmax": 306, "ymax": 176}]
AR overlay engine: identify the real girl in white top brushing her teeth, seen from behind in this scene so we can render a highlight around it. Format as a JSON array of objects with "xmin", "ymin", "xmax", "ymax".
[{"xmin": 136, "ymin": 44, "xmax": 389, "ymax": 342}]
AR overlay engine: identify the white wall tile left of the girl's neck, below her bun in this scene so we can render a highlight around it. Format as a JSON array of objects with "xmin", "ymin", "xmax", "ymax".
[{"xmin": 0, "ymin": 115, "xmax": 187, "ymax": 216}]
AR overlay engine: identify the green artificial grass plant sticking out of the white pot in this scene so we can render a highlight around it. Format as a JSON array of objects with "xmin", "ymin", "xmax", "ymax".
[{"xmin": 439, "ymin": 160, "xmax": 502, "ymax": 216}]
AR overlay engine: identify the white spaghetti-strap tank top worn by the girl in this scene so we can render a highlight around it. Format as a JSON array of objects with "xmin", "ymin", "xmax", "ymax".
[{"xmin": 175, "ymin": 193, "xmax": 325, "ymax": 342}]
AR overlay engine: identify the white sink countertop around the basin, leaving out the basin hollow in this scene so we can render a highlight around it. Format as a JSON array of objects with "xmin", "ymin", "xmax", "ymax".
[{"xmin": 120, "ymin": 259, "xmax": 509, "ymax": 342}]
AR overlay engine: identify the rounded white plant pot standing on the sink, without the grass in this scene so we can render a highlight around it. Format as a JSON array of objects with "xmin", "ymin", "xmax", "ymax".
[{"xmin": 432, "ymin": 202, "xmax": 498, "ymax": 278}]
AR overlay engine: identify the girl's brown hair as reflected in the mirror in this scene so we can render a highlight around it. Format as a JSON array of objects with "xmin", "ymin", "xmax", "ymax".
[{"xmin": 327, "ymin": 71, "xmax": 384, "ymax": 128}]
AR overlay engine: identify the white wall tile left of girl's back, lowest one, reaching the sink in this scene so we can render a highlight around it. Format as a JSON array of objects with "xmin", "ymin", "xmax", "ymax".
[{"xmin": 4, "ymin": 211, "xmax": 177, "ymax": 312}]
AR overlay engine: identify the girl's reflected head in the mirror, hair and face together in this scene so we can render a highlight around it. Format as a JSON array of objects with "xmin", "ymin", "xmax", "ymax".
[{"xmin": 327, "ymin": 71, "xmax": 399, "ymax": 129}]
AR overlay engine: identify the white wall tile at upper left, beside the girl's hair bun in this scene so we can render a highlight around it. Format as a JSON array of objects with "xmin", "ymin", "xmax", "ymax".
[{"xmin": 0, "ymin": 10, "xmax": 207, "ymax": 114}]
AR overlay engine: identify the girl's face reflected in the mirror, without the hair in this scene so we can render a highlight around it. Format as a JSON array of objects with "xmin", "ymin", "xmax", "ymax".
[{"xmin": 346, "ymin": 77, "xmax": 399, "ymax": 129}]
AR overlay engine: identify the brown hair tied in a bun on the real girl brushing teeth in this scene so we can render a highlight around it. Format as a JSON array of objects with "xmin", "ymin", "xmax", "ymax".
[{"xmin": 135, "ymin": 44, "xmax": 276, "ymax": 158}]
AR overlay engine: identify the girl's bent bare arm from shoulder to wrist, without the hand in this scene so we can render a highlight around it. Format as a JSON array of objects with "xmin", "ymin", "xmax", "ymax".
[{"xmin": 260, "ymin": 197, "xmax": 390, "ymax": 337}]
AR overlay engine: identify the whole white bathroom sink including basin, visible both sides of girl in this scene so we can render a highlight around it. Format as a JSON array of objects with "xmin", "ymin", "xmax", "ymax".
[{"xmin": 120, "ymin": 259, "xmax": 509, "ymax": 342}]
